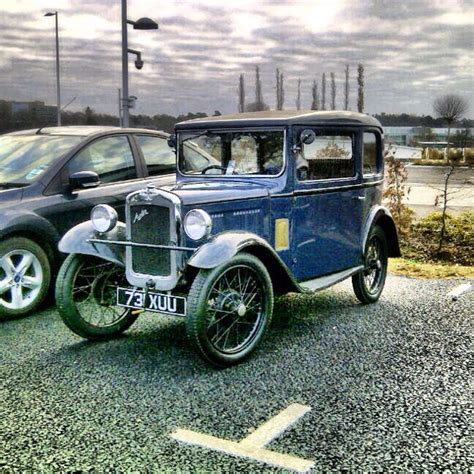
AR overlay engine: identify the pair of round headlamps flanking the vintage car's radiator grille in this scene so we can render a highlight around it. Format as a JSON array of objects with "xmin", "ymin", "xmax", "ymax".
[{"xmin": 91, "ymin": 204, "xmax": 212, "ymax": 240}]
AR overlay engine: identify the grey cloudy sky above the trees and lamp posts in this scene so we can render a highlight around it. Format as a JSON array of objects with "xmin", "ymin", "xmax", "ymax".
[{"xmin": 0, "ymin": 0, "xmax": 474, "ymax": 116}]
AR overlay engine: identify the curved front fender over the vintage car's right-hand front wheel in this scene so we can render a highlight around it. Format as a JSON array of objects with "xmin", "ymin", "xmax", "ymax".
[{"xmin": 187, "ymin": 232, "xmax": 301, "ymax": 293}]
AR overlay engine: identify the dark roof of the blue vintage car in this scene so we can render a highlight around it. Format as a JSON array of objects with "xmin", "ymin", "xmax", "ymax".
[{"xmin": 176, "ymin": 110, "xmax": 382, "ymax": 130}]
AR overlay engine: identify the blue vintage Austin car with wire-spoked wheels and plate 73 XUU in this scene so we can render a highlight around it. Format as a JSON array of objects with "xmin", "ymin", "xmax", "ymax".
[{"xmin": 56, "ymin": 111, "xmax": 400, "ymax": 366}]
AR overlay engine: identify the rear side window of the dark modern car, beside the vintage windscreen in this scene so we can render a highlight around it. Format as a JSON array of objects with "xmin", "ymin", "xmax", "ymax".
[{"xmin": 136, "ymin": 135, "xmax": 176, "ymax": 176}]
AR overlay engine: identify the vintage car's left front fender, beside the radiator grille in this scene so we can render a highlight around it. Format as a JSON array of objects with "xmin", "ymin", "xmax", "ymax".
[{"xmin": 59, "ymin": 221, "xmax": 126, "ymax": 267}]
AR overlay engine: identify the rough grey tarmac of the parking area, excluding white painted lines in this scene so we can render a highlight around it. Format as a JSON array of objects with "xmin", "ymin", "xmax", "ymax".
[{"xmin": 0, "ymin": 276, "xmax": 474, "ymax": 472}]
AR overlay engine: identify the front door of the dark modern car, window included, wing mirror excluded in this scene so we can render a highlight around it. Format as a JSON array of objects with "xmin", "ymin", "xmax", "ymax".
[{"xmin": 38, "ymin": 134, "xmax": 151, "ymax": 235}]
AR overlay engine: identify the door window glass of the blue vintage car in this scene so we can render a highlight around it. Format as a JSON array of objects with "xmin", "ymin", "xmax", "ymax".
[{"xmin": 296, "ymin": 131, "xmax": 355, "ymax": 181}]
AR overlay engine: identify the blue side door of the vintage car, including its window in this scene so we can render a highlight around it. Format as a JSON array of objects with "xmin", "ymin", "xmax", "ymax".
[{"xmin": 292, "ymin": 127, "xmax": 364, "ymax": 280}]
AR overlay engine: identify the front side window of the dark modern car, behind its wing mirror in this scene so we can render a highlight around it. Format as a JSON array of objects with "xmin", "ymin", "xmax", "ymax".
[{"xmin": 68, "ymin": 135, "xmax": 137, "ymax": 183}]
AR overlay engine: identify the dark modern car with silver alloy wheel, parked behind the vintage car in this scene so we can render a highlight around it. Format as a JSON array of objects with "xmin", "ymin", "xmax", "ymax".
[{"xmin": 0, "ymin": 126, "xmax": 176, "ymax": 319}]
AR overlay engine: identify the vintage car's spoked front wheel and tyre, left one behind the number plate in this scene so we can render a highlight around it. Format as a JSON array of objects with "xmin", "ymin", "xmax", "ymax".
[{"xmin": 56, "ymin": 254, "xmax": 138, "ymax": 340}]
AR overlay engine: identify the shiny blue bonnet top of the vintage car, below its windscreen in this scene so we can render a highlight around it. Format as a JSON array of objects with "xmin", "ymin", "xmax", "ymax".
[{"xmin": 169, "ymin": 180, "xmax": 269, "ymax": 206}]
